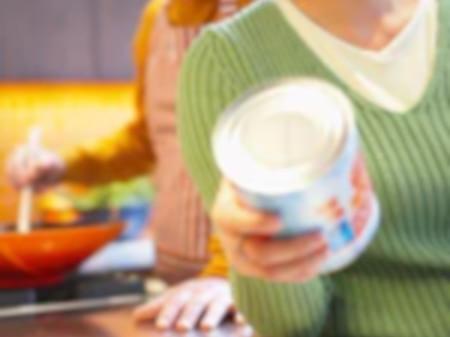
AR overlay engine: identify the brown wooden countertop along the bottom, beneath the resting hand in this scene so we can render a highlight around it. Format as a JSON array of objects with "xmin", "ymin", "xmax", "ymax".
[{"xmin": 0, "ymin": 307, "xmax": 253, "ymax": 337}]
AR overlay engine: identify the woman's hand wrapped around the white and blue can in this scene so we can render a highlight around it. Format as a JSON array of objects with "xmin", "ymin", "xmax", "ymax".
[{"xmin": 212, "ymin": 181, "xmax": 328, "ymax": 282}]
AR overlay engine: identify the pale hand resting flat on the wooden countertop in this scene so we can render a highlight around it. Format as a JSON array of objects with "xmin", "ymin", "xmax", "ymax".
[{"xmin": 134, "ymin": 277, "xmax": 242, "ymax": 331}]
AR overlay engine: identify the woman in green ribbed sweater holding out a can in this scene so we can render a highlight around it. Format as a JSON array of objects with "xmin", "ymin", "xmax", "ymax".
[{"xmin": 178, "ymin": 0, "xmax": 450, "ymax": 337}]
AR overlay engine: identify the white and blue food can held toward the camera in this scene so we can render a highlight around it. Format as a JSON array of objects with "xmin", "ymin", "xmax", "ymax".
[{"xmin": 212, "ymin": 78, "xmax": 380, "ymax": 273}]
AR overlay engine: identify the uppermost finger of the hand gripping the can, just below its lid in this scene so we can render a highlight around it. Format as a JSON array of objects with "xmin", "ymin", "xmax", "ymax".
[{"xmin": 211, "ymin": 181, "xmax": 281, "ymax": 235}]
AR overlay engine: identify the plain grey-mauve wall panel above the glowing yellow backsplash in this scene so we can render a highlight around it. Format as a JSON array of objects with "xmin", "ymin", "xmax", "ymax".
[{"xmin": 0, "ymin": 0, "xmax": 148, "ymax": 80}]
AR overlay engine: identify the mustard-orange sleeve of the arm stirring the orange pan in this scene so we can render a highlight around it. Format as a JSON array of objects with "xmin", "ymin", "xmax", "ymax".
[{"xmin": 64, "ymin": 0, "xmax": 165, "ymax": 185}]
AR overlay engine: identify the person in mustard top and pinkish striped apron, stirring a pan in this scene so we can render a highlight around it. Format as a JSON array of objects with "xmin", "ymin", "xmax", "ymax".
[{"xmin": 7, "ymin": 0, "xmax": 249, "ymax": 330}]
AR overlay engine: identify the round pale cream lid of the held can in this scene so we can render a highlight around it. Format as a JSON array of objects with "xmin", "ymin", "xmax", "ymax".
[{"xmin": 213, "ymin": 78, "xmax": 354, "ymax": 194}]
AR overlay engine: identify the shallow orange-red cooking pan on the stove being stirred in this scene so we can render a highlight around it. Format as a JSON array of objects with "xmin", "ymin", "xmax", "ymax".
[{"xmin": 0, "ymin": 222, "xmax": 123, "ymax": 288}]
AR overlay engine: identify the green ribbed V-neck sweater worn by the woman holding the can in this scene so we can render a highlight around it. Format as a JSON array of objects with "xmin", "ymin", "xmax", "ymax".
[{"xmin": 178, "ymin": 0, "xmax": 450, "ymax": 337}]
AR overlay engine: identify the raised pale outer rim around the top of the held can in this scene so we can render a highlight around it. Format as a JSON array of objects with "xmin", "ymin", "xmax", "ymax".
[{"xmin": 212, "ymin": 77, "xmax": 354, "ymax": 195}]
